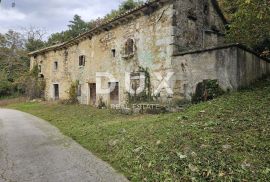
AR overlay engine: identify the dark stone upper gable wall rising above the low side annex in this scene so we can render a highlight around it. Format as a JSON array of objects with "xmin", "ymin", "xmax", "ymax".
[{"xmin": 173, "ymin": 0, "xmax": 225, "ymax": 53}]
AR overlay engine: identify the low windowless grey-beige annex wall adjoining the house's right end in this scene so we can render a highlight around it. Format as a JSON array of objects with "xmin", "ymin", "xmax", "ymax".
[{"xmin": 172, "ymin": 46, "xmax": 270, "ymax": 100}]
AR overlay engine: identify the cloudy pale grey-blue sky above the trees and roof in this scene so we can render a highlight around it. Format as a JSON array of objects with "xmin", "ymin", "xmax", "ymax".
[{"xmin": 0, "ymin": 0, "xmax": 126, "ymax": 37}]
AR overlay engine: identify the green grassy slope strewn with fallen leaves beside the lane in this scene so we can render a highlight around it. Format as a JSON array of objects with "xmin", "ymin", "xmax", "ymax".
[{"xmin": 5, "ymin": 80, "xmax": 270, "ymax": 181}]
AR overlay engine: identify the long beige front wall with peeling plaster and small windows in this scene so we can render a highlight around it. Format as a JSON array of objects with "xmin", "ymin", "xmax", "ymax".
[{"xmin": 32, "ymin": 3, "xmax": 173, "ymax": 104}]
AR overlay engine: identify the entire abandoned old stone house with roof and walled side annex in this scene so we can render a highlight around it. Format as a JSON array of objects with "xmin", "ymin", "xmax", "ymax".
[{"xmin": 29, "ymin": 0, "xmax": 270, "ymax": 105}]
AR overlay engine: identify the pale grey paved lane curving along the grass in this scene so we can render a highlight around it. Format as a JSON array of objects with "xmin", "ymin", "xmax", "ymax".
[{"xmin": 0, "ymin": 109, "xmax": 127, "ymax": 182}]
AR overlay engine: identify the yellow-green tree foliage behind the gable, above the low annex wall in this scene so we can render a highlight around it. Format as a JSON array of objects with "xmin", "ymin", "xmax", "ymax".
[{"xmin": 220, "ymin": 0, "xmax": 270, "ymax": 58}]
